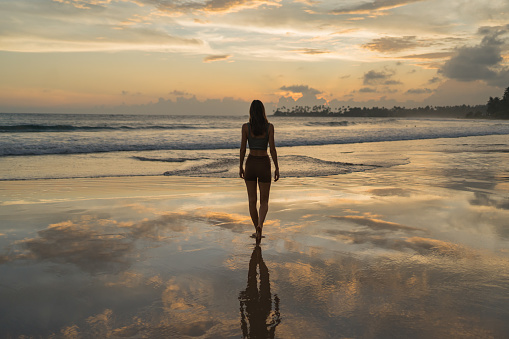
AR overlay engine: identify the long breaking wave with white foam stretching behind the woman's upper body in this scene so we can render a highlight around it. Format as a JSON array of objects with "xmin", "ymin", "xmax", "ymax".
[{"xmin": 0, "ymin": 129, "xmax": 509, "ymax": 157}]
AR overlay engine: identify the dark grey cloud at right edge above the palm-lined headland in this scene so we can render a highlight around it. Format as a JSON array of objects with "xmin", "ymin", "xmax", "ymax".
[{"xmin": 439, "ymin": 25, "xmax": 509, "ymax": 87}]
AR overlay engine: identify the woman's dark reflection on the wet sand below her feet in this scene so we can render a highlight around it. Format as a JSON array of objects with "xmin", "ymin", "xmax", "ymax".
[{"xmin": 239, "ymin": 245, "xmax": 281, "ymax": 338}]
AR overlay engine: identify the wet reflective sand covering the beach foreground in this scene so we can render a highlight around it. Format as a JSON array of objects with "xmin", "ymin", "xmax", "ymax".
[{"xmin": 0, "ymin": 137, "xmax": 509, "ymax": 338}]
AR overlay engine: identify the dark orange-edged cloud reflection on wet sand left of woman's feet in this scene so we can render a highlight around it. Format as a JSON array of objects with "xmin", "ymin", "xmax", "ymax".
[{"xmin": 9, "ymin": 211, "xmax": 258, "ymax": 274}]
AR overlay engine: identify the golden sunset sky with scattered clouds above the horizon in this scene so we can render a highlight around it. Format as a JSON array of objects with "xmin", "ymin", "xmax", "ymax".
[{"xmin": 0, "ymin": 0, "xmax": 509, "ymax": 114}]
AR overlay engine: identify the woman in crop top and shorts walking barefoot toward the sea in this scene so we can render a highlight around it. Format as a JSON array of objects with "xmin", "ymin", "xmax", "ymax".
[{"xmin": 239, "ymin": 100, "xmax": 279, "ymax": 243}]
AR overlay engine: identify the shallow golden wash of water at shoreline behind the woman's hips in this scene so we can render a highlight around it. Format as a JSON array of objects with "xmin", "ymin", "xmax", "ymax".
[{"xmin": 0, "ymin": 135, "xmax": 509, "ymax": 183}]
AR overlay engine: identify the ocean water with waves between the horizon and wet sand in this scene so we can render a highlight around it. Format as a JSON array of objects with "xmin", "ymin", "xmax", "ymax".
[{"xmin": 0, "ymin": 113, "xmax": 509, "ymax": 180}]
